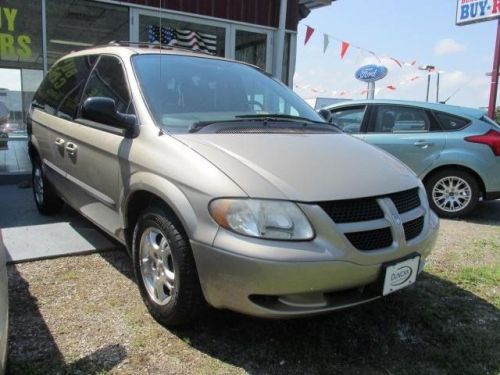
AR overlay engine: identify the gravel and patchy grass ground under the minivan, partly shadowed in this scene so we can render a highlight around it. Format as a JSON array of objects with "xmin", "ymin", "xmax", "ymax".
[{"xmin": 4, "ymin": 206, "xmax": 500, "ymax": 375}]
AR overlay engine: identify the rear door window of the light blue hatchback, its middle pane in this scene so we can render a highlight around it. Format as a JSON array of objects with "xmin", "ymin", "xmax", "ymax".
[{"xmin": 372, "ymin": 106, "xmax": 430, "ymax": 133}]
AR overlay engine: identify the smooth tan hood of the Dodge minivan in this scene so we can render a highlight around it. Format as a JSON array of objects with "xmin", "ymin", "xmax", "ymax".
[{"xmin": 174, "ymin": 134, "xmax": 418, "ymax": 202}]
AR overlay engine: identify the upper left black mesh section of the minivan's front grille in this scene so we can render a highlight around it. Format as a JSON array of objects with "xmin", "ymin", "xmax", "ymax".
[{"xmin": 318, "ymin": 198, "xmax": 384, "ymax": 223}]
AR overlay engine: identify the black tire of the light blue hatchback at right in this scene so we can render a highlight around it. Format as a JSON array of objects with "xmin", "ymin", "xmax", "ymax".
[{"xmin": 425, "ymin": 168, "xmax": 481, "ymax": 219}]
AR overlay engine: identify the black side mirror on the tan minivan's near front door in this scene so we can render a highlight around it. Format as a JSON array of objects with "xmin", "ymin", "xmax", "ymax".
[{"xmin": 82, "ymin": 96, "xmax": 137, "ymax": 131}]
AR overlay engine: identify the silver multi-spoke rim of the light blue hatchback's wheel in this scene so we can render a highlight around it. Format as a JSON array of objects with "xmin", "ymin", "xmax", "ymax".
[{"xmin": 432, "ymin": 176, "xmax": 472, "ymax": 212}]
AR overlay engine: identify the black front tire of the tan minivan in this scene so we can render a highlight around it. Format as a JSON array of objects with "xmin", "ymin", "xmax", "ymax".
[{"xmin": 132, "ymin": 207, "xmax": 207, "ymax": 326}]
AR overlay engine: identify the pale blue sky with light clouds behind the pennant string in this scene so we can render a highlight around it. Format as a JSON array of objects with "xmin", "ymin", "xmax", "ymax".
[{"xmin": 294, "ymin": 0, "xmax": 497, "ymax": 107}]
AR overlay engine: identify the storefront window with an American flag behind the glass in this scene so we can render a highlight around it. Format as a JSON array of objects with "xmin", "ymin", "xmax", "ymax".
[{"xmin": 139, "ymin": 15, "xmax": 226, "ymax": 57}]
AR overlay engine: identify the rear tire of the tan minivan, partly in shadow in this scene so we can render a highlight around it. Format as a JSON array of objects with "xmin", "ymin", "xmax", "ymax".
[{"xmin": 31, "ymin": 159, "xmax": 64, "ymax": 215}]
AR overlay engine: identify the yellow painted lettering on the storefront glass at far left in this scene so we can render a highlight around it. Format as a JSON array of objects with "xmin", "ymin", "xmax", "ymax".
[{"xmin": 0, "ymin": 7, "xmax": 32, "ymax": 60}]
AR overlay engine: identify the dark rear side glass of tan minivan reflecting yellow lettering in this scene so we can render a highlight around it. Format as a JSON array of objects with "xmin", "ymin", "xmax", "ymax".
[{"xmin": 34, "ymin": 56, "xmax": 96, "ymax": 119}]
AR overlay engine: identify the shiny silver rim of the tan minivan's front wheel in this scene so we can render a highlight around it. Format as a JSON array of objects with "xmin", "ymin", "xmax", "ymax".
[{"xmin": 139, "ymin": 227, "xmax": 175, "ymax": 305}]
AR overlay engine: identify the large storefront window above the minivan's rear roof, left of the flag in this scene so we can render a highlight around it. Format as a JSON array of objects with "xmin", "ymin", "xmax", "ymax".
[{"xmin": 47, "ymin": 0, "xmax": 129, "ymax": 67}]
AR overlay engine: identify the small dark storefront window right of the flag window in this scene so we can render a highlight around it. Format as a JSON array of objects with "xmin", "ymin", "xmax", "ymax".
[{"xmin": 235, "ymin": 30, "xmax": 267, "ymax": 70}]
